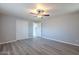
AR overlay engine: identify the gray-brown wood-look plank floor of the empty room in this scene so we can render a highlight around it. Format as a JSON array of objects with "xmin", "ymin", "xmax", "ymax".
[{"xmin": 0, "ymin": 38, "xmax": 79, "ymax": 55}]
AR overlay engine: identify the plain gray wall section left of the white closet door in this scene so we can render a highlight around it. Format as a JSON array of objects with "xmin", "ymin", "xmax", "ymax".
[{"xmin": 0, "ymin": 16, "xmax": 16, "ymax": 43}]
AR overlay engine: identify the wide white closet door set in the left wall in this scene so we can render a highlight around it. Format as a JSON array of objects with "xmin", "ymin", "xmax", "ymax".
[{"xmin": 16, "ymin": 20, "xmax": 28, "ymax": 40}]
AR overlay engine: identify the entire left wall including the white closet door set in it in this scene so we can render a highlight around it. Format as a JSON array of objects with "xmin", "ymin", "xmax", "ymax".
[{"xmin": 0, "ymin": 15, "xmax": 29, "ymax": 44}]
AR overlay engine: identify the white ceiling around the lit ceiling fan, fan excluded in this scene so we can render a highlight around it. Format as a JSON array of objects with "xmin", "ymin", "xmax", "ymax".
[{"xmin": 0, "ymin": 3, "xmax": 79, "ymax": 20}]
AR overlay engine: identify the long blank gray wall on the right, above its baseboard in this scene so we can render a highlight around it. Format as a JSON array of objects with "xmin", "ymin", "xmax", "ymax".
[{"xmin": 42, "ymin": 12, "xmax": 79, "ymax": 45}]
